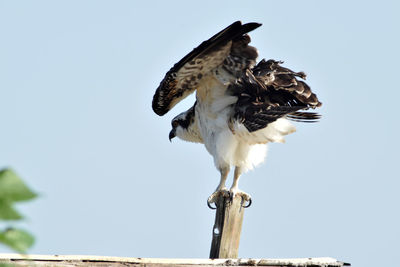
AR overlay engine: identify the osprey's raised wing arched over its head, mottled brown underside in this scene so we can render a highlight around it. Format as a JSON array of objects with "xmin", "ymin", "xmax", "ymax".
[{"xmin": 152, "ymin": 21, "xmax": 261, "ymax": 116}]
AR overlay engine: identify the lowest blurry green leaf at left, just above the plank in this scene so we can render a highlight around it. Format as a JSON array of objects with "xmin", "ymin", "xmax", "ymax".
[{"xmin": 0, "ymin": 229, "xmax": 35, "ymax": 253}]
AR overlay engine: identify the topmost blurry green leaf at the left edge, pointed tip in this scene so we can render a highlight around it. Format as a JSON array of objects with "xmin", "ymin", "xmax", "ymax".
[{"xmin": 0, "ymin": 169, "xmax": 37, "ymax": 202}]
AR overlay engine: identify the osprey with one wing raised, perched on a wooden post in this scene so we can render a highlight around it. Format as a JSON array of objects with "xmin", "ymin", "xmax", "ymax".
[{"xmin": 152, "ymin": 21, "xmax": 321, "ymax": 206}]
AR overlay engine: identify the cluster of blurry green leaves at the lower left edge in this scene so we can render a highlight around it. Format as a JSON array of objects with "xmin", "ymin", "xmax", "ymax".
[{"xmin": 0, "ymin": 169, "xmax": 37, "ymax": 253}]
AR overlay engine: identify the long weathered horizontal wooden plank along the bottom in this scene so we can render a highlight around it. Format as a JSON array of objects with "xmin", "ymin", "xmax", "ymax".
[{"xmin": 0, "ymin": 254, "xmax": 350, "ymax": 267}]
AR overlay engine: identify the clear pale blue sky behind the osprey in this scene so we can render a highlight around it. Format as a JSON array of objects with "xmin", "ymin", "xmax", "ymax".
[{"xmin": 0, "ymin": 0, "xmax": 400, "ymax": 267}]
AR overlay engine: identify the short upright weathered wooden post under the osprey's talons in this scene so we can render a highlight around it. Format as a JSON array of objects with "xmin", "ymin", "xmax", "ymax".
[{"xmin": 210, "ymin": 194, "xmax": 244, "ymax": 259}]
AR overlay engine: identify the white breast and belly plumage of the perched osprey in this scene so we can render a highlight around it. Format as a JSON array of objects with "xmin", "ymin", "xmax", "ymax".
[{"xmin": 195, "ymin": 71, "xmax": 295, "ymax": 171}]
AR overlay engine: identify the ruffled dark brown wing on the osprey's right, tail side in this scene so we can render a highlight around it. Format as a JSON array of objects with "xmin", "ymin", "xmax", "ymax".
[{"xmin": 229, "ymin": 60, "xmax": 322, "ymax": 132}]
